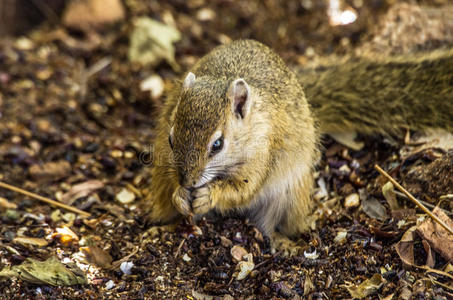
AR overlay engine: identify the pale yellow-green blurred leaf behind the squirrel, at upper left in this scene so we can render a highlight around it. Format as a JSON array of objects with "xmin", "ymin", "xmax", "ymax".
[{"xmin": 128, "ymin": 17, "xmax": 181, "ymax": 70}]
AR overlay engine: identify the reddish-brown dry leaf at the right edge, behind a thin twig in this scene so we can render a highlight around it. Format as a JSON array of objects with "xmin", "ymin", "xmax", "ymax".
[{"xmin": 417, "ymin": 207, "xmax": 453, "ymax": 261}]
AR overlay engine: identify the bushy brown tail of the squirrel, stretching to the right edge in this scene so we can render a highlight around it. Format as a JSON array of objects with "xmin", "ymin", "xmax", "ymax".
[{"xmin": 298, "ymin": 49, "xmax": 453, "ymax": 134}]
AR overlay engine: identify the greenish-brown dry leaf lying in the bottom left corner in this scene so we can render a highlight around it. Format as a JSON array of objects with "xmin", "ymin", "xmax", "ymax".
[{"xmin": 0, "ymin": 256, "xmax": 87, "ymax": 286}]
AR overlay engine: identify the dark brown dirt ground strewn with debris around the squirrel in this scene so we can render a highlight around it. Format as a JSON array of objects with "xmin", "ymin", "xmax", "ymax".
[{"xmin": 0, "ymin": 0, "xmax": 453, "ymax": 299}]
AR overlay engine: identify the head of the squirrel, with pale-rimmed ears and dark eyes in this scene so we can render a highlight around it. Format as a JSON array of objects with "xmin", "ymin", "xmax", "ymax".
[{"xmin": 168, "ymin": 73, "xmax": 264, "ymax": 188}]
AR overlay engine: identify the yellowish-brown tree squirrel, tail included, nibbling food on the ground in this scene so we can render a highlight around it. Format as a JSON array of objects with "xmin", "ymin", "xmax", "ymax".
[{"xmin": 147, "ymin": 40, "xmax": 453, "ymax": 252}]
